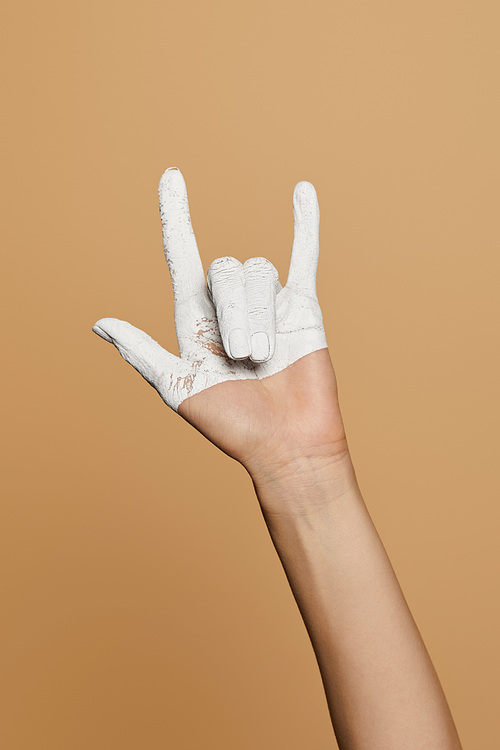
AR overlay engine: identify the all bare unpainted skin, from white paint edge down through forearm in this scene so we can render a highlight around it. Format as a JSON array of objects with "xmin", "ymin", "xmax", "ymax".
[{"xmin": 179, "ymin": 349, "xmax": 461, "ymax": 750}]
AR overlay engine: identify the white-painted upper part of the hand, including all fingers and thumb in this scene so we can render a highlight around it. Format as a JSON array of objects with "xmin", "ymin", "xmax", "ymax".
[{"xmin": 93, "ymin": 168, "xmax": 327, "ymax": 418}]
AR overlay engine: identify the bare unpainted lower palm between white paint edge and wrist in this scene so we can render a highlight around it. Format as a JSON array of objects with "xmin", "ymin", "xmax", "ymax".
[{"xmin": 179, "ymin": 349, "xmax": 346, "ymax": 470}]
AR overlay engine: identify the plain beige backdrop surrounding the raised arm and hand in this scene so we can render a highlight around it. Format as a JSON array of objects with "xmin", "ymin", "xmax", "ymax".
[{"xmin": 0, "ymin": 0, "xmax": 500, "ymax": 750}]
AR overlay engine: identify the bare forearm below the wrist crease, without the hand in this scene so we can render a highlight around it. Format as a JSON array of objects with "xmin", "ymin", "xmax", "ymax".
[{"xmin": 249, "ymin": 458, "xmax": 460, "ymax": 750}]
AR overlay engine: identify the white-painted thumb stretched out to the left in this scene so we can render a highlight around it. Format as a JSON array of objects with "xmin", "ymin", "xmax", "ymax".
[{"xmin": 92, "ymin": 318, "xmax": 185, "ymax": 411}]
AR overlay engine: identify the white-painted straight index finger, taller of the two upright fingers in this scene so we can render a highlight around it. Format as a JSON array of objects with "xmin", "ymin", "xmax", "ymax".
[{"xmin": 158, "ymin": 167, "xmax": 206, "ymax": 302}]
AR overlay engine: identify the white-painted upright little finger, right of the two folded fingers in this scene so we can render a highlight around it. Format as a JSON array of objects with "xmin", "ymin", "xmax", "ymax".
[{"xmin": 286, "ymin": 181, "xmax": 319, "ymax": 296}]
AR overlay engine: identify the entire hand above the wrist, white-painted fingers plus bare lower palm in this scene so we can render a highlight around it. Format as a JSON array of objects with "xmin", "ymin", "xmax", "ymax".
[{"xmin": 93, "ymin": 168, "xmax": 347, "ymax": 484}]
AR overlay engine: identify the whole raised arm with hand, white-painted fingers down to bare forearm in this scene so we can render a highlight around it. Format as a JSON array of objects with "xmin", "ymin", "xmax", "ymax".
[{"xmin": 94, "ymin": 169, "xmax": 460, "ymax": 750}]
